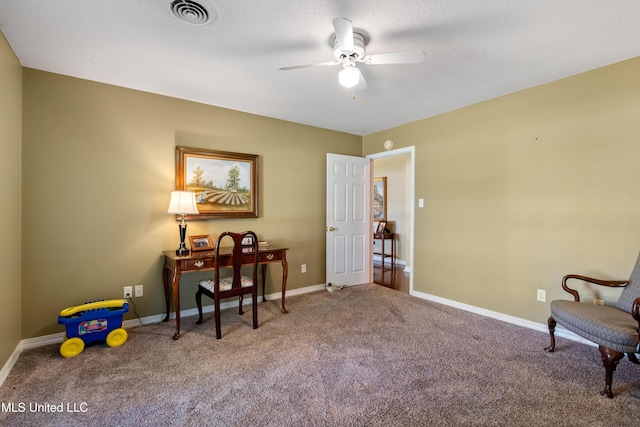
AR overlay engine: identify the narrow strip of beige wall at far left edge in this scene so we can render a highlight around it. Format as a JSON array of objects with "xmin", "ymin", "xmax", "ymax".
[{"xmin": 0, "ymin": 33, "xmax": 22, "ymax": 366}]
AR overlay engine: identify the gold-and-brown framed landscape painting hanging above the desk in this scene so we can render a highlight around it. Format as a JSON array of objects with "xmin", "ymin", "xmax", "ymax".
[{"xmin": 176, "ymin": 146, "xmax": 258, "ymax": 220}]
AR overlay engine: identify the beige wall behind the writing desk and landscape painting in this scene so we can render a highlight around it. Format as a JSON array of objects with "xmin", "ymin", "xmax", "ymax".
[{"xmin": 22, "ymin": 69, "xmax": 361, "ymax": 338}]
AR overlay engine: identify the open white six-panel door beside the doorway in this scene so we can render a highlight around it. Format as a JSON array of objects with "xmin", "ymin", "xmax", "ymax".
[{"xmin": 326, "ymin": 154, "xmax": 372, "ymax": 286}]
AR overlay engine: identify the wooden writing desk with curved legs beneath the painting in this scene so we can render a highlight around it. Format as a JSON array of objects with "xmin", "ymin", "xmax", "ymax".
[{"xmin": 162, "ymin": 247, "xmax": 288, "ymax": 340}]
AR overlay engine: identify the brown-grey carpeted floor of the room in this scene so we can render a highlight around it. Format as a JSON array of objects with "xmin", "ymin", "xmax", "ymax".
[{"xmin": 0, "ymin": 285, "xmax": 640, "ymax": 426}]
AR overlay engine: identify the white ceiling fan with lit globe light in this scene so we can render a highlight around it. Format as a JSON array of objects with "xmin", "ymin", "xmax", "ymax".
[{"xmin": 278, "ymin": 18, "xmax": 425, "ymax": 88}]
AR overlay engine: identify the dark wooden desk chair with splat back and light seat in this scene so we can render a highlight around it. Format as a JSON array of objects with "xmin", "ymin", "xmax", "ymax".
[{"xmin": 196, "ymin": 231, "xmax": 258, "ymax": 339}]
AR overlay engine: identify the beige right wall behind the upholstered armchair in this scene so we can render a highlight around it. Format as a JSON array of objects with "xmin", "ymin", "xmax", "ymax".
[{"xmin": 363, "ymin": 58, "xmax": 640, "ymax": 322}]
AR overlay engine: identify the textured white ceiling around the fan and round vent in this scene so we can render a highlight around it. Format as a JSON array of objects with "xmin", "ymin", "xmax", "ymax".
[{"xmin": 0, "ymin": 0, "xmax": 640, "ymax": 135}]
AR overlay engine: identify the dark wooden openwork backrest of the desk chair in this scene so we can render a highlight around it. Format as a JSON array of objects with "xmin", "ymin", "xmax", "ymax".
[{"xmin": 214, "ymin": 231, "xmax": 259, "ymax": 290}]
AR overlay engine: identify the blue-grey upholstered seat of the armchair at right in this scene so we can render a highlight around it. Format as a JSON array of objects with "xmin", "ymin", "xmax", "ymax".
[{"xmin": 551, "ymin": 300, "xmax": 640, "ymax": 353}]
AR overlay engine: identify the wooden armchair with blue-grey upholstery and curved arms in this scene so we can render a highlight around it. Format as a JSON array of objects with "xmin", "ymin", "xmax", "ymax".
[{"xmin": 544, "ymin": 256, "xmax": 640, "ymax": 398}]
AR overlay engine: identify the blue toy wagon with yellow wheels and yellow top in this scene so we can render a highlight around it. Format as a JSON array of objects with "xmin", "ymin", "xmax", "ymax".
[{"xmin": 58, "ymin": 299, "xmax": 129, "ymax": 357}]
